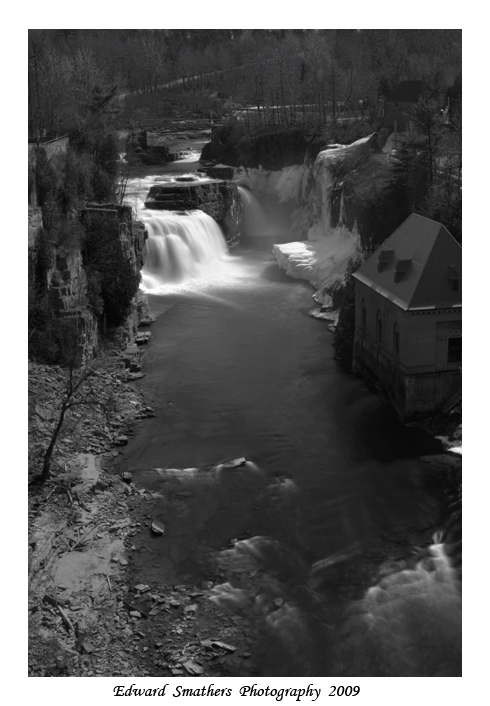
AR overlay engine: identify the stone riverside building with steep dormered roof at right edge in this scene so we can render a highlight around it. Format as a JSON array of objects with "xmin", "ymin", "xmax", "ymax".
[{"xmin": 352, "ymin": 214, "xmax": 462, "ymax": 421}]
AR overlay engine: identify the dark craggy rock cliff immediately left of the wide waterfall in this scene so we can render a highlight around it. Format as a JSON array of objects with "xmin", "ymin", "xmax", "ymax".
[{"xmin": 29, "ymin": 204, "xmax": 147, "ymax": 362}]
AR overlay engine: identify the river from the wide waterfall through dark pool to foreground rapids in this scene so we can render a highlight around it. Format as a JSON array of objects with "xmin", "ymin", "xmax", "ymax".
[{"xmin": 121, "ymin": 173, "xmax": 461, "ymax": 676}]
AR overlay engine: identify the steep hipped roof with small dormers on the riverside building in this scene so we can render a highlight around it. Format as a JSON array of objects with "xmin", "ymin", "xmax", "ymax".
[{"xmin": 354, "ymin": 213, "xmax": 462, "ymax": 310}]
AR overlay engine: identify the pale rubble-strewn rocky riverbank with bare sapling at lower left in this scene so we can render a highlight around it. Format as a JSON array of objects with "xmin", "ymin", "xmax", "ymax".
[{"xmin": 28, "ymin": 356, "xmax": 256, "ymax": 677}]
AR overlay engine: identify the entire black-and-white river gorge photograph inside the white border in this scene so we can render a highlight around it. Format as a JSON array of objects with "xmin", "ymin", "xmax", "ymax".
[{"xmin": 27, "ymin": 24, "xmax": 462, "ymax": 680}]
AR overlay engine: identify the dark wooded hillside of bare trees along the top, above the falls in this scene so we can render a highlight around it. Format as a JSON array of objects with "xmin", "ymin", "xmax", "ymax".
[{"xmin": 29, "ymin": 29, "xmax": 461, "ymax": 137}]
